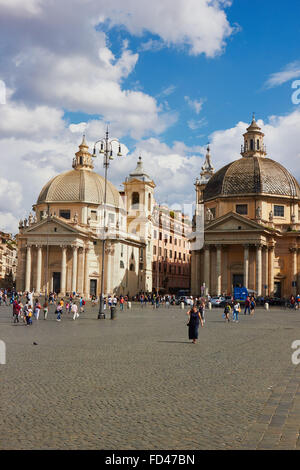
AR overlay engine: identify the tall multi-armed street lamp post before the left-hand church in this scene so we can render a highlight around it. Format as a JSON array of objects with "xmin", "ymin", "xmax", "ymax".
[{"xmin": 93, "ymin": 128, "xmax": 122, "ymax": 319}]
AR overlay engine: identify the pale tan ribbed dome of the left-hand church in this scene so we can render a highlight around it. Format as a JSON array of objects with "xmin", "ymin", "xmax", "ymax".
[{"xmin": 37, "ymin": 168, "xmax": 124, "ymax": 208}]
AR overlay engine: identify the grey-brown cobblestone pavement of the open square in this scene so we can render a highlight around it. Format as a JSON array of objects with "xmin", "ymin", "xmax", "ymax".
[{"xmin": 0, "ymin": 305, "xmax": 300, "ymax": 450}]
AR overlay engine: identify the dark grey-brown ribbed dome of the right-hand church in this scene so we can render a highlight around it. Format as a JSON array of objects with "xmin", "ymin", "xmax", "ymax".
[{"xmin": 203, "ymin": 157, "xmax": 300, "ymax": 201}]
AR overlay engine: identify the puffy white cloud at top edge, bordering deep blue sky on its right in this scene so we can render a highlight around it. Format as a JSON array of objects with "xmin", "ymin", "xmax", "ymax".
[{"xmin": 99, "ymin": 0, "xmax": 233, "ymax": 57}]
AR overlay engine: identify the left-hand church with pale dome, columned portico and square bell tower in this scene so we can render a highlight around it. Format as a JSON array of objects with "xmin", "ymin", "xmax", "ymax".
[{"xmin": 16, "ymin": 137, "xmax": 188, "ymax": 298}]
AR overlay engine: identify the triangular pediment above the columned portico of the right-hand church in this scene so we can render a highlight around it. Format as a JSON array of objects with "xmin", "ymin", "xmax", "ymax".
[{"xmin": 205, "ymin": 212, "xmax": 273, "ymax": 232}]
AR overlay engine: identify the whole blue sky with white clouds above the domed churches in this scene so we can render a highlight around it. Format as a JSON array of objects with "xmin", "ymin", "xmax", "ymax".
[{"xmin": 0, "ymin": 0, "xmax": 300, "ymax": 231}]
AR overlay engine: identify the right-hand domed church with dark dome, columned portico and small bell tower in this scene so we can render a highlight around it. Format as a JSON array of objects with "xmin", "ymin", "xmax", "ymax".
[{"xmin": 191, "ymin": 117, "xmax": 300, "ymax": 297}]
